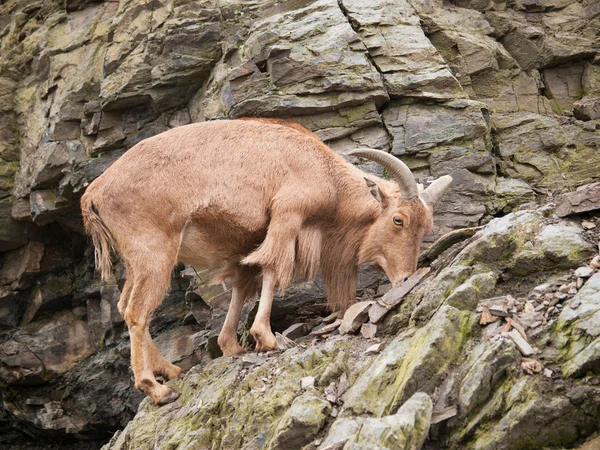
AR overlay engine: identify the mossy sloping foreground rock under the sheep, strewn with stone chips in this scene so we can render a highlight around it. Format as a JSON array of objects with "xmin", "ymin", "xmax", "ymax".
[{"xmin": 104, "ymin": 210, "xmax": 600, "ymax": 450}]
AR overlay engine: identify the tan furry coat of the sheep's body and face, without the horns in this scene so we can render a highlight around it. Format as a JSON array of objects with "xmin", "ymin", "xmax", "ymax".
[{"xmin": 81, "ymin": 119, "xmax": 440, "ymax": 403}]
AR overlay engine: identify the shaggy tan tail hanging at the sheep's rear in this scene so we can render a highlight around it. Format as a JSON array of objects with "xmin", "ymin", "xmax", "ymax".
[{"xmin": 81, "ymin": 195, "xmax": 117, "ymax": 281}]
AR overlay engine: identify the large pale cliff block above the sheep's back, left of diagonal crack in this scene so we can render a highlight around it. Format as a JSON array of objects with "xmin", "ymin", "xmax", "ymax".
[{"xmin": 204, "ymin": 0, "xmax": 389, "ymax": 117}]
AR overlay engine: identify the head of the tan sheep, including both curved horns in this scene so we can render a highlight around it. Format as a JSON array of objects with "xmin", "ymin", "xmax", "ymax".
[{"xmin": 348, "ymin": 149, "xmax": 452, "ymax": 286}]
